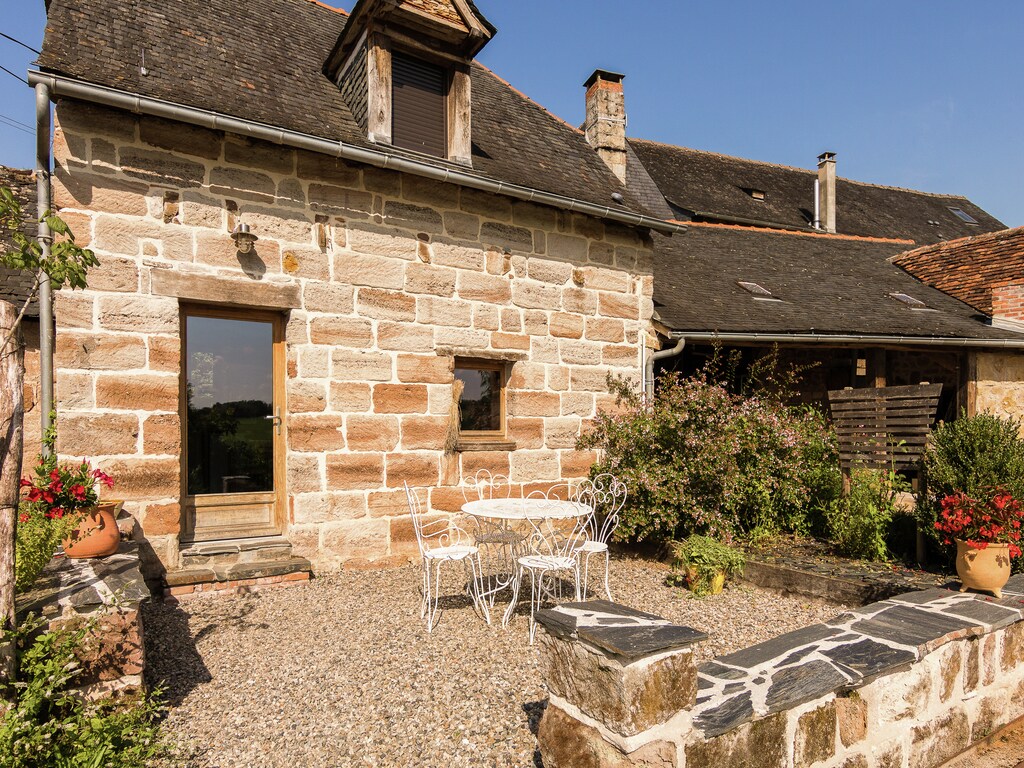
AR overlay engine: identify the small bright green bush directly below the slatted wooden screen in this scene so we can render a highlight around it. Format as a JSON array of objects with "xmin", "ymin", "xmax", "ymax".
[{"xmin": 825, "ymin": 469, "xmax": 909, "ymax": 560}]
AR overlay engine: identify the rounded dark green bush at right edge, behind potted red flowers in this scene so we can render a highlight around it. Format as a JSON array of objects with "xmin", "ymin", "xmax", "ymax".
[{"xmin": 918, "ymin": 414, "xmax": 1024, "ymax": 545}]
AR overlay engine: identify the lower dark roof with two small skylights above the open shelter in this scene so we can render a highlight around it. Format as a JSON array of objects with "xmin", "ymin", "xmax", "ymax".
[{"xmin": 654, "ymin": 223, "xmax": 1024, "ymax": 341}]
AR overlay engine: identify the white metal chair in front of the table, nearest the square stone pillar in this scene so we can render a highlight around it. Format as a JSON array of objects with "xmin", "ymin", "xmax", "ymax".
[{"xmin": 502, "ymin": 489, "xmax": 587, "ymax": 645}]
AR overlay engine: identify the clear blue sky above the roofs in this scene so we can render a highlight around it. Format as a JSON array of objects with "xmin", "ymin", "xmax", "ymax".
[{"xmin": 0, "ymin": 0, "xmax": 1024, "ymax": 226}]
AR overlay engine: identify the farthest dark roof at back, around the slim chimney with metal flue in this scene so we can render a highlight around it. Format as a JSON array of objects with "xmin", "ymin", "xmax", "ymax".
[{"xmin": 629, "ymin": 139, "xmax": 1006, "ymax": 245}]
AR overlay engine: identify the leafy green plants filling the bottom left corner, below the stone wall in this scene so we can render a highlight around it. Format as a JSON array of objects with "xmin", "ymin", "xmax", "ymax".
[{"xmin": 0, "ymin": 621, "xmax": 173, "ymax": 768}]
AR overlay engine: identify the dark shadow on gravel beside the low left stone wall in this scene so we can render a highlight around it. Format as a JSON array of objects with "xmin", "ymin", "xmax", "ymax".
[{"xmin": 142, "ymin": 601, "xmax": 214, "ymax": 707}]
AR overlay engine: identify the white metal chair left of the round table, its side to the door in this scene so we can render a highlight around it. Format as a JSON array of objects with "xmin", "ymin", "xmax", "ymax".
[{"xmin": 406, "ymin": 482, "xmax": 490, "ymax": 633}]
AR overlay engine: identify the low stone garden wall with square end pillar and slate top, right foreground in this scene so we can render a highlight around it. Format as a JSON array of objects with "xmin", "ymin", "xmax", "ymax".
[{"xmin": 539, "ymin": 575, "xmax": 1024, "ymax": 768}]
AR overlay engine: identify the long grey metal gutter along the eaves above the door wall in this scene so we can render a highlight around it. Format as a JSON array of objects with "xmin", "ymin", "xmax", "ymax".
[{"xmin": 29, "ymin": 72, "xmax": 686, "ymax": 240}]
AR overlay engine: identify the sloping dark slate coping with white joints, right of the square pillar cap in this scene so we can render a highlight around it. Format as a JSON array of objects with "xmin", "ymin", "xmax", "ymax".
[{"xmin": 691, "ymin": 574, "xmax": 1024, "ymax": 738}]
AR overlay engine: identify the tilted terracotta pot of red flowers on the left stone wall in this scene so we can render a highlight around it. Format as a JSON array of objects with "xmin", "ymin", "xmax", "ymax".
[{"xmin": 22, "ymin": 455, "xmax": 121, "ymax": 558}]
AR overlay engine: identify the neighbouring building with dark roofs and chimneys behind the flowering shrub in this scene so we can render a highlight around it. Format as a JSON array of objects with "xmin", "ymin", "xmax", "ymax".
[{"xmin": 585, "ymin": 73, "xmax": 1024, "ymax": 419}]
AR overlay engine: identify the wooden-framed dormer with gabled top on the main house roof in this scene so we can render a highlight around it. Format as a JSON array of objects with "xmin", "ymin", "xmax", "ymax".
[{"xmin": 324, "ymin": 0, "xmax": 495, "ymax": 165}]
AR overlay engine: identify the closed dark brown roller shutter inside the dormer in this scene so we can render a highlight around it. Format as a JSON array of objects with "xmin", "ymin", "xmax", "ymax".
[{"xmin": 391, "ymin": 52, "xmax": 447, "ymax": 158}]
